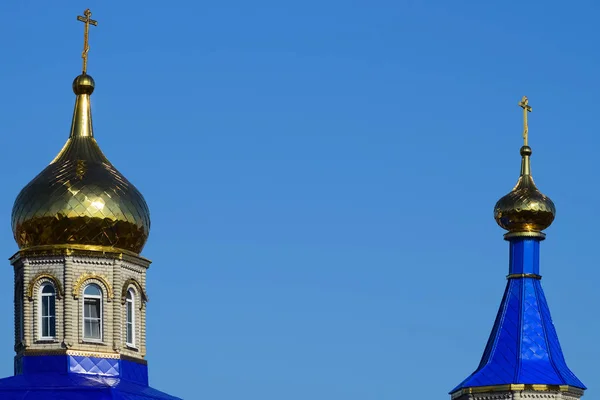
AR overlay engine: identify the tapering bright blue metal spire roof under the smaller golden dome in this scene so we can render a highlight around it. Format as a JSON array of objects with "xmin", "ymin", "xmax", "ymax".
[{"xmin": 450, "ymin": 239, "xmax": 586, "ymax": 393}]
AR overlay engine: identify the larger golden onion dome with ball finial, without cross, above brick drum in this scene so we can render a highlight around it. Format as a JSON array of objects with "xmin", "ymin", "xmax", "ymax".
[{"xmin": 12, "ymin": 73, "xmax": 150, "ymax": 254}]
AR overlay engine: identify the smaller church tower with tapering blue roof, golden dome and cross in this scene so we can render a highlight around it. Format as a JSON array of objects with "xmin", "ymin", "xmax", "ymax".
[{"xmin": 450, "ymin": 97, "xmax": 586, "ymax": 400}]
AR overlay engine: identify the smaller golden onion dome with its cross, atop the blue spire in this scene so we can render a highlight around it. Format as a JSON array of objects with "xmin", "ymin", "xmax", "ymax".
[{"xmin": 494, "ymin": 97, "xmax": 556, "ymax": 236}]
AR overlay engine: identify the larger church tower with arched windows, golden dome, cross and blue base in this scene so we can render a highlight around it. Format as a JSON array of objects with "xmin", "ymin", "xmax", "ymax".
[{"xmin": 0, "ymin": 10, "xmax": 176, "ymax": 400}]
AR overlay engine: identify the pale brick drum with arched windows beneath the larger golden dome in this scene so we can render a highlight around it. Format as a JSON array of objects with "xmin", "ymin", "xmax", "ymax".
[{"xmin": 10, "ymin": 249, "xmax": 150, "ymax": 360}]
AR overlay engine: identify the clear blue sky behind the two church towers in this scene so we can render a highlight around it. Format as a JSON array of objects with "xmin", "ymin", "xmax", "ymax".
[{"xmin": 0, "ymin": 0, "xmax": 600, "ymax": 400}]
